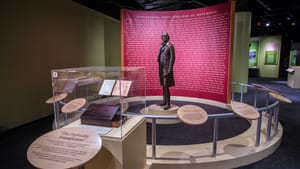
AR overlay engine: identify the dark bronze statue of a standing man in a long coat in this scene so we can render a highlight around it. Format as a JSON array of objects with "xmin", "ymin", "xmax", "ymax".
[{"xmin": 157, "ymin": 32, "xmax": 175, "ymax": 110}]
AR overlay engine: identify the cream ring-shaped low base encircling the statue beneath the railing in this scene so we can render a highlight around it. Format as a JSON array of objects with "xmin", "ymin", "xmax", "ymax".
[{"xmin": 125, "ymin": 97, "xmax": 283, "ymax": 169}]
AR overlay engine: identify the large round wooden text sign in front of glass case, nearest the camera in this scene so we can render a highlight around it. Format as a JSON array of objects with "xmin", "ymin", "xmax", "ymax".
[{"xmin": 27, "ymin": 127, "xmax": 102, "ymax": 169}]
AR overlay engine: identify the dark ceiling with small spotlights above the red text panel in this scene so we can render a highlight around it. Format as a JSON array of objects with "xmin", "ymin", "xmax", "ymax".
[{"xmin": 74, "ymin": 0, "xmax": 300, "ymax": 41}]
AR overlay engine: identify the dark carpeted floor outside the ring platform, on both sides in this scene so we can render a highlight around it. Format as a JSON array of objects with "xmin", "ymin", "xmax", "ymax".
[{"xmin": 0, "ymin": 78, "xmax": 300, "ymax": 169}]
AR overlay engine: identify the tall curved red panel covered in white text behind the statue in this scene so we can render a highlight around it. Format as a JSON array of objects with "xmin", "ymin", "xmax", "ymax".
[{"xmin": 121, "ymin": 3, "xmax": 231, "ymax": 103}]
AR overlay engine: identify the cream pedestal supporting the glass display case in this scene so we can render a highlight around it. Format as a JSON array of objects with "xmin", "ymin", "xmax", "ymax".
[{"xmin": 66, "ymin": 116, "xmax": 146, "ymax": 169}]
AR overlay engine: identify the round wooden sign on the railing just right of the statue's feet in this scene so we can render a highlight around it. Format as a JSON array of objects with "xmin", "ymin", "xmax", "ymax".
[{"xmin": 177, "ymin": 105, "xmax": 208, "ymax": 125}]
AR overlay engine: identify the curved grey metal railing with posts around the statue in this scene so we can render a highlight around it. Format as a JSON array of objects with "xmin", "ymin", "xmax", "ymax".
[{"xmin": 145, "ymin": 82, "xmax": 279, "ymax": 159}]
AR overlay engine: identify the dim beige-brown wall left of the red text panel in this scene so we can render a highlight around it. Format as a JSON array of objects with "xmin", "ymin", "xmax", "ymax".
[{"xmin": 0, "ymin": 0, "xmax": 120, "ymax": 132}]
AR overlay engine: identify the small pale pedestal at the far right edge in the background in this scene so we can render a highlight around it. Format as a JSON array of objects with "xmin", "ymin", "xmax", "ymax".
[{"xmin": 286, "ymin": 66, "xmax": 300, "ymax": 88}]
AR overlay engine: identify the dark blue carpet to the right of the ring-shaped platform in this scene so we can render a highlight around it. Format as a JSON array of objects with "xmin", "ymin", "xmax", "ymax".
[{"xmin": 239, "ymin": 78, "xmax": 300, "ymax": 169}]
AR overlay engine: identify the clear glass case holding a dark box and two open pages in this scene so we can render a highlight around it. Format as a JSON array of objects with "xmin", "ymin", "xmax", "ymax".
[{"xmin": 47, "ymin": 67, "xmax": 146, "ymax": 137}]
